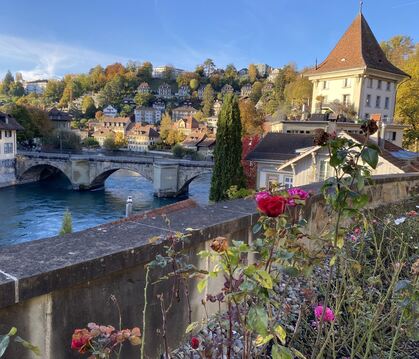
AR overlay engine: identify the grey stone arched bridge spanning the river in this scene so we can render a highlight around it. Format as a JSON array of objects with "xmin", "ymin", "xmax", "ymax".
[{"xmin": 16, "ymin": 152, "xmax": 213, "ymax": 197}]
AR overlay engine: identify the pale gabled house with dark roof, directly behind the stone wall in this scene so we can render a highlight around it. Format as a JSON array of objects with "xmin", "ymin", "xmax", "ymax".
[{"xmin": 246, "ymin": 132, "xmax": 419, "ymax": 189}]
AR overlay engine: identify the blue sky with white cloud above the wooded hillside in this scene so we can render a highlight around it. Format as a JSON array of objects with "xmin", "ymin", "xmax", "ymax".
[{"xmin": 0, "ymin": 0, "xmax": 419, "ymax": 80}]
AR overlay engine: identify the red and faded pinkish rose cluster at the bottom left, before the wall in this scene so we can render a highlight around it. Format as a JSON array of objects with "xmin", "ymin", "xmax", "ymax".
[{"xmin": 71, "ymin": 323, "xmax": 141, "ymax": 358}]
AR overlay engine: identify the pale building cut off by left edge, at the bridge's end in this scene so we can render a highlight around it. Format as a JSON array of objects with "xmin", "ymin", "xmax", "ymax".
[{"xmin": 0, "ymin": 112, "xmax": 23, "ymax": 187}]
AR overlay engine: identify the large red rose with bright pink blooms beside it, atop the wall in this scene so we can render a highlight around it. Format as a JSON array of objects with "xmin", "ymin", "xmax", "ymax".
[{"xmin": 256, "ymin": 188, "xmax": 310, "ymax": 217}]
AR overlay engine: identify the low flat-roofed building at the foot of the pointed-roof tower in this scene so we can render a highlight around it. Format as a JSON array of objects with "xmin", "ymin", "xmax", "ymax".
[{"xmin": 269, "ymin": 114, "xmax": 405, "ymax": 147}]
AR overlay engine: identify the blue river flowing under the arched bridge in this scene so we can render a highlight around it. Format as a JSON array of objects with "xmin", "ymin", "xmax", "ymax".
[{"xmin": 0, "ymin": 170, "xmax": 210, "ymax": 246}]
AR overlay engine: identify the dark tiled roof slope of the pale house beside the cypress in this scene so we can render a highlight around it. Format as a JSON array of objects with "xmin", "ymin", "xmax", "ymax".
[{"xmin": 246, "ymin": 133, "xmax": 314, "ymax": 161}]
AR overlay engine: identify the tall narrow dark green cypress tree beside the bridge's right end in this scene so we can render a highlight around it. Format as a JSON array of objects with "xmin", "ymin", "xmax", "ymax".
[{"xmin": 210, "ymin": 94, "xmax": 245, "ymax": 202}]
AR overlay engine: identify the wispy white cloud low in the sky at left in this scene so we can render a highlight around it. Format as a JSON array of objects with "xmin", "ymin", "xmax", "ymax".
[{"xmin": 0, "ymin": 34, "xmax": 127, "ymax": 80}]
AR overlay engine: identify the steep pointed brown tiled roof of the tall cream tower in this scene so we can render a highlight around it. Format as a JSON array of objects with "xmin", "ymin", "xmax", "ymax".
[{"xmin": 307, "ymin": 13, "xmax": 409, "ymax": 77}]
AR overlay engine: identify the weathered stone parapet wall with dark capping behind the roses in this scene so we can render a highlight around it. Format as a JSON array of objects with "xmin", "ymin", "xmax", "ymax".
[{"xmin": 0, "ymin": 174, "xmax": 419, "ymax": 359}]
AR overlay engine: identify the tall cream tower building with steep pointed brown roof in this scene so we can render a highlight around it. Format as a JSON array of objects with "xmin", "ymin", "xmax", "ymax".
[{"xmin": 305, "ymin": 13, "xmax": 409, "ymax": 123}]
